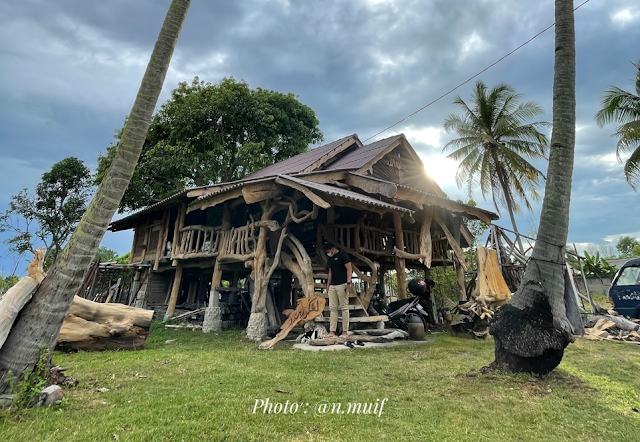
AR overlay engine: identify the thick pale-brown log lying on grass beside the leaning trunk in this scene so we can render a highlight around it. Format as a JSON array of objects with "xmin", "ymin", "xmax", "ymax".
[{"xmin": 58, "ymin": 296, "xmax": 153, "ymax": 350}]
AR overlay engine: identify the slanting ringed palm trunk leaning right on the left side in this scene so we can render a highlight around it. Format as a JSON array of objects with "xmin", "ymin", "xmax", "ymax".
[{"xmin": 0, "ymin": 0, "xmax": 191, "ymax": 393}]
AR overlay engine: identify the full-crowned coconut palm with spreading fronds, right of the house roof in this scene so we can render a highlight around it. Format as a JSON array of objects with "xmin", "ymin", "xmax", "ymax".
[{"xmin": 443, "ymin": 81, "xmax": 549, "ymax": 249}]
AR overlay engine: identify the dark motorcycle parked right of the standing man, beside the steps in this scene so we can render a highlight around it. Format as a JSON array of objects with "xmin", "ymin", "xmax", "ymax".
[{"xmin": 368, "ymin": 279, "xmax": 435, "ymax": 332}]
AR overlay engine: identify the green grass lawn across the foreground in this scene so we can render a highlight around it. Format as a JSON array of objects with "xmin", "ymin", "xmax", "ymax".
[{"xmin": 0, "ymin": 324, "xmax": 640, "ymax": 442}]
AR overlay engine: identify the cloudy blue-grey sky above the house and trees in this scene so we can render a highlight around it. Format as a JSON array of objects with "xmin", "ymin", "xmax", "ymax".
[{"xmin": 0, "ymin": 0, "xmax": 640, "ymax": 272}]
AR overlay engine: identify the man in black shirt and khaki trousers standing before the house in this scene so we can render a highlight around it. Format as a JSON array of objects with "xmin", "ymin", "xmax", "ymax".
[{"xmin": 324, "ymin": 243, "xmax": 351, "ymax": 338}]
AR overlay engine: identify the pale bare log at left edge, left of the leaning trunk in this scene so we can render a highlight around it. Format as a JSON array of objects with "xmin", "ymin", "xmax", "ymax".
[{"xmin": 0, "ymin": 248, "xmax": 46, "ymax": 348}]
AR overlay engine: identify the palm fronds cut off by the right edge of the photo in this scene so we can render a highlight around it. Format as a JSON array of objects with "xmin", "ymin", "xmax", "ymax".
[{"xmin": 596, "ymin": 62, "xmax": 640, "ymax": 191}]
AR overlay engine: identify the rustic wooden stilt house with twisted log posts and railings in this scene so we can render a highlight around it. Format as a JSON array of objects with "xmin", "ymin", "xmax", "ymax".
[{"xmin": 110, "ymin": 134, "xmax": 498, "ymax": 334}]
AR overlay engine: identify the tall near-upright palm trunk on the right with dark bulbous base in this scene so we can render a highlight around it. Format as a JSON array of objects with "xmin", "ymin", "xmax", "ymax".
[{"xmin": 491, "ymin": 0, "xmax": 578, "ymax": 374}]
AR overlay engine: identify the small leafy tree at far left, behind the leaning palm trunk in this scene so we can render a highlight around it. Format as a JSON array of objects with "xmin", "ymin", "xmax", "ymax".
[{"xmin": 0, "ymin": 157, "xmax": 92, "ymax": 269}]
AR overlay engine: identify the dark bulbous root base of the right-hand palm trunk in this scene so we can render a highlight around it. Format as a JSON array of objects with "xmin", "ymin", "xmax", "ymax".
[{"xmin": 483, "ymin": 298, "xmax": 573, "ymax": 375}]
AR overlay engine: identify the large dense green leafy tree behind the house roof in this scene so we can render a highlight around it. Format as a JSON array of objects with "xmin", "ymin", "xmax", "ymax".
[{"xmin": 97, "ymin": 77, "xmax": 322, "ymax": 211}]
